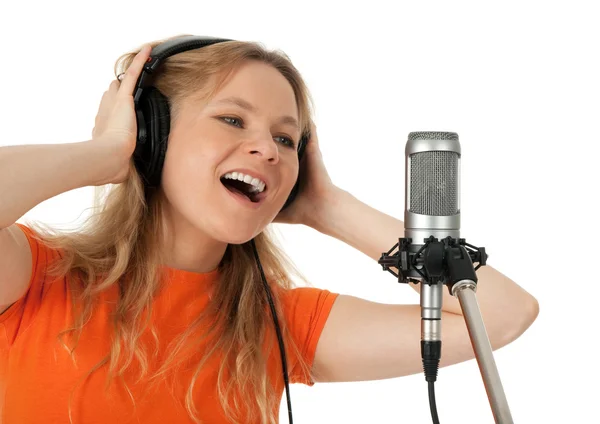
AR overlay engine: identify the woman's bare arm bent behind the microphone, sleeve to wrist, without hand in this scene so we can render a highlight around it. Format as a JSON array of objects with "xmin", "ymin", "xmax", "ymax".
[{"xmin": 313, "ymin": 190, "xmax": 539, "ymax": 381}]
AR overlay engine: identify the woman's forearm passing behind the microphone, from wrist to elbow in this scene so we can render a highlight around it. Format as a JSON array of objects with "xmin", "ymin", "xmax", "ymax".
[{"xmin": 311, "ymin": 189, "xmax": 538, "ymax": 319}]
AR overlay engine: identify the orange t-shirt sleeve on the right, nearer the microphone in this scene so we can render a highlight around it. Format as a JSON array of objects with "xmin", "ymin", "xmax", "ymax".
[{"xmin": 283, "ymin": 287, "xmax": 338, "ymax": 386}]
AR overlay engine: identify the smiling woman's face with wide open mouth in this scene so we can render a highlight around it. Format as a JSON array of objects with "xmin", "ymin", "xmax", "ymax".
[{"xmin": 162, "ymin": 61, "xmax": 300, "ymax": 244}]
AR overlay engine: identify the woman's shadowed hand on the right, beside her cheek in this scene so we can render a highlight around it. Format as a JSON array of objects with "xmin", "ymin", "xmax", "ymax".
[{"xmin": 273, "ymin": 123, "xmax": 337, "ymax": 226}]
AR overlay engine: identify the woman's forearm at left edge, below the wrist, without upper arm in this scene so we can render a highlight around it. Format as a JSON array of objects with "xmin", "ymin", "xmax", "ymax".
[{"xmin": 0, "ymin": 141, "xmax": 105, "ymax": 228}]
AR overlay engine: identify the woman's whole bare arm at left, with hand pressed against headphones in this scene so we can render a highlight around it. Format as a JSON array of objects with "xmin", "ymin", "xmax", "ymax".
[{"xmin": 0, "ymin": 45, "xmax": 150, "ymax": 313}]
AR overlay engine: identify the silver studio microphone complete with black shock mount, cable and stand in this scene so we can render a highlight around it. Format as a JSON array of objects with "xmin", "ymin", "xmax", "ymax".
[{"xmin": 378, "ymin": 131, "xmax": 512, "ymax": 424}]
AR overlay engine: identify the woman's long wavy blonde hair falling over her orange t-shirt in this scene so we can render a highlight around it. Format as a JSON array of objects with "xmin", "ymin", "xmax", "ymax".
[{"xmin": 27, "ymin": 34, "xmax": 313, "ymax": 424}]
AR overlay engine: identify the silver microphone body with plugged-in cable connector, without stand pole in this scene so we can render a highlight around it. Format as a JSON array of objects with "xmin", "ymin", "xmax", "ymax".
[{"xmin": 404, "ymin": 131, "xmax": 461, "ymax": 382}]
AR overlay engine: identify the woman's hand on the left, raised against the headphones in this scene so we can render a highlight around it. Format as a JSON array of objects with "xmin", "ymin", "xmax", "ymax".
[{"xmin": 92, "ymin": 45, "xmax": 151, "ymax": 185}]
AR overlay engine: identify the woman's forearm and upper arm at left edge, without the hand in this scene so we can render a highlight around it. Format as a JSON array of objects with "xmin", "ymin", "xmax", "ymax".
[{"xmin": 0, "ymin": 142, "xmax": 116, "ymax": 313}]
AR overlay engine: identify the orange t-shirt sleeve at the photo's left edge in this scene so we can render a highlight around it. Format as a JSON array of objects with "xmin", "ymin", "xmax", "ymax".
[{"xmin": 0, "ymin": 223, "xmax": 58, "ymax": 351}]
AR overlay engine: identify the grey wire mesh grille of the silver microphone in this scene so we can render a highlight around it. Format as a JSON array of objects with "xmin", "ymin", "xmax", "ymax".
[{"xmin": 409, "ymin": 150, "xmax": 459, "ymax": 216}]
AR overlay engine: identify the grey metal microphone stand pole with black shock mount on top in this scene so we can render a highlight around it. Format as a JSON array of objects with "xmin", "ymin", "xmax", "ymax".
[{"xmin": 378, "ymin": 236, "xmax": 513, "ymax": 424}]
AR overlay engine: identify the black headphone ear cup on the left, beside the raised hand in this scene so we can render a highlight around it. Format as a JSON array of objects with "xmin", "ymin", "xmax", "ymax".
[{"xmin": 133, "ymin": 87, "xmax": 171, "ymax": 187}]
